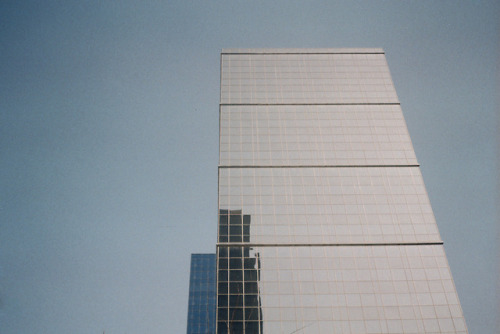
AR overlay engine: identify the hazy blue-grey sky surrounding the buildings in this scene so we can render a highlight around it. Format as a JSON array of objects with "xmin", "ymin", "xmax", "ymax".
[{"xmin": 0, "ymin": 0, "xmax": 500, "ymax": 334}]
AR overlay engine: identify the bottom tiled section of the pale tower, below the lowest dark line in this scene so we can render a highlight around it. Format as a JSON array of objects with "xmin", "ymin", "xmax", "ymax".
[{"xmin": 218, "ymin": 245, "xmax": 466, "ymax": 334}]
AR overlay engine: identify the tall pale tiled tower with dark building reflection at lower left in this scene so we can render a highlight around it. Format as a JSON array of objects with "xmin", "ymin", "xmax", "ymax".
[{"xmin": 217, "ymin": 49, "xmax": 467, "ymax": 334}]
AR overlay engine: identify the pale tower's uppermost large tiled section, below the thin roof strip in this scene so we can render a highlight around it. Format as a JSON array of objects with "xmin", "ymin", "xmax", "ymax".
[{"xmin": 220, "ymin": 54, "xmax": 399, "ymax": 104}]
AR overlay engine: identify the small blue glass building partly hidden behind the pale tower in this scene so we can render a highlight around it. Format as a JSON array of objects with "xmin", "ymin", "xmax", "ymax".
[{"xmin": 187, "ymin": 254, "xmax": 217, "ymax": 334}]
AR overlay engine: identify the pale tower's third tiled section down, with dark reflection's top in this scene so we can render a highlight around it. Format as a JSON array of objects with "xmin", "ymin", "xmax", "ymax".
[{"xmin": 219, "ymin": 167, "xmax": 441, "ymax": 244}]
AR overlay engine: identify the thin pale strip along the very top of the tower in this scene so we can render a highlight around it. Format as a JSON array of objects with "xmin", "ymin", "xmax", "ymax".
[{"xmin": 221, "ymin": 48, "xmax": 384, "ymax": 54}]
